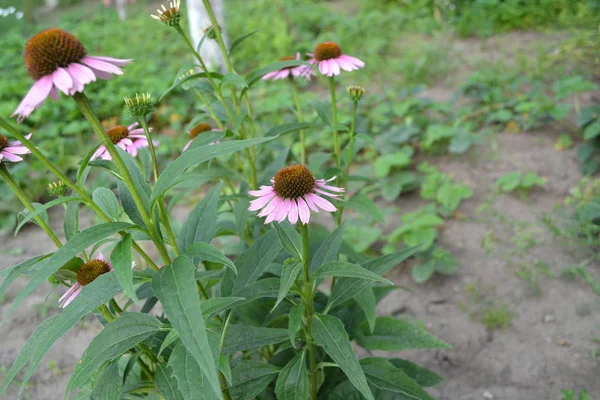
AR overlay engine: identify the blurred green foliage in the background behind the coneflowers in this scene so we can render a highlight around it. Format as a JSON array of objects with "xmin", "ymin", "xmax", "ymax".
[{"xmin": 0, "ymin": 0, "xmax": 600, "ymax": 234}]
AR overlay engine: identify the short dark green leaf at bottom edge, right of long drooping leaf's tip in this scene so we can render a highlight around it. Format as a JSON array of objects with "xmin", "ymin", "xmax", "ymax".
[{"xmin": 229, "ymin": 360, "xmax": 279, "ymax": 400}]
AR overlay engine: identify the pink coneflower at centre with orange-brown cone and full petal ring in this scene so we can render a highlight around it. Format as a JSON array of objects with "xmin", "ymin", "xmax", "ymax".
[{"xmin": 248, "ymin": 165, "xmax": 344, "ymax": 224}]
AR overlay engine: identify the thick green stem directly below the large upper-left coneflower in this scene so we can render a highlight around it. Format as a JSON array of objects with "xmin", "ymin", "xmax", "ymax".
[{"xmin": 73, "ymin": 93, "xmax": 171, "ymax": 264}]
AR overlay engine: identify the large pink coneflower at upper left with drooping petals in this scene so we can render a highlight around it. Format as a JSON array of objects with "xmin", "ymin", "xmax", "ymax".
[{"xmin": 12, "ymin": 28, "xmax": 131, "ymax": 122}]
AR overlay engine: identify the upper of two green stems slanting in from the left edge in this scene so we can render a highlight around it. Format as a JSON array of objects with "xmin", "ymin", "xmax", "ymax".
[{"xmin": 0, "ymin": 117, "xmax": 158, "ymax": 271}]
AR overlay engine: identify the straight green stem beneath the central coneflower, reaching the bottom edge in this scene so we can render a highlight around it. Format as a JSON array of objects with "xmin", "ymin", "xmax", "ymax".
[{"xmin": 300, "ymin": 224, "xmax": 318, "ymax": 400}]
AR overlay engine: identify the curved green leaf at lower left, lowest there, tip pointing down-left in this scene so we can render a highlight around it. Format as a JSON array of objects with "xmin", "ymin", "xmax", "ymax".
[{"xmin": 67, "ymin": 312, "xmax": 162, "ymax": 393}]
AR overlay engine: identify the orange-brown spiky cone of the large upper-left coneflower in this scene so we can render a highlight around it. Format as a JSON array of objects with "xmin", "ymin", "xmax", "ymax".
[{"xmin": 25, "ymin": 28, "xmax": 87, "ymax": 80}]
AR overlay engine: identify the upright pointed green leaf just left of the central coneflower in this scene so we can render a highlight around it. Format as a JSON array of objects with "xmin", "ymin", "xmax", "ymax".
[{"xmin": 177, "ymin": 184, "xmax": 222, "ymax": 249}]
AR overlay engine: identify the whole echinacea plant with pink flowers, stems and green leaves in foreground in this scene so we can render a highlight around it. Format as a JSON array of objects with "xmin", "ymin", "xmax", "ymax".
[{"xmin": 0, "ymin": 0, "xmax": 449, "ymax": 400}]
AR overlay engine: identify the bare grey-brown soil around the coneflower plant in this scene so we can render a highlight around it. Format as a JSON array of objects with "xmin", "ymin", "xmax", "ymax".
[{"xmin": 0, "ymin": 33, "xmax": 600, "ymax": 400}]
